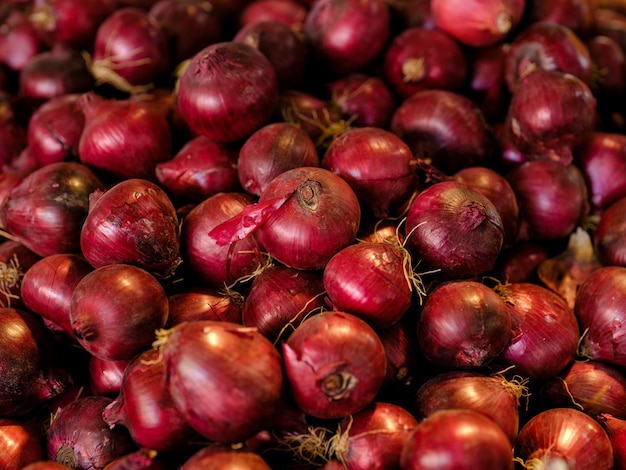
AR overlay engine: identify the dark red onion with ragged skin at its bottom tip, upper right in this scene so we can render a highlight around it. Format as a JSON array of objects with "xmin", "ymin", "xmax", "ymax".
[{"xmin": 506, "ymin": 69, "xmax": 597, "ymax": 165}]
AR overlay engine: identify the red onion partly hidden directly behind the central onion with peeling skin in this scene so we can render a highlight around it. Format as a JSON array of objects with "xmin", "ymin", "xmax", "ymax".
[{"xmin": 237, "ymin": 122, "xmax": 320, "ymax": 196}]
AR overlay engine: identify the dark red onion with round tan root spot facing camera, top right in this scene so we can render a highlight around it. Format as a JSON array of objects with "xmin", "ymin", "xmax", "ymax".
[{"xmin": 384, "ymin": 27, "xmax": 468, "ymax": 98}]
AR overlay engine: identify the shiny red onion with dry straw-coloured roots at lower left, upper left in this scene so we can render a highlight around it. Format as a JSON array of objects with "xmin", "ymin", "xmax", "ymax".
[{"xmin": 88, "ymin": 7, "xmax": 170, "ymax": 92}]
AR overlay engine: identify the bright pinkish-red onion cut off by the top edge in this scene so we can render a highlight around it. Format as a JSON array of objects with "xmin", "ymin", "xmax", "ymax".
[{"xmin": 430, "ymin": 0, "xmax": 526, "ymax": 47}]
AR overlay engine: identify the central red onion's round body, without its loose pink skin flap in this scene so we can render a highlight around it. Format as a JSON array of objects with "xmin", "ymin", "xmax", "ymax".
[{"xmin": 258, "ymin": 167, "xmax": 361, "ymax": 270}]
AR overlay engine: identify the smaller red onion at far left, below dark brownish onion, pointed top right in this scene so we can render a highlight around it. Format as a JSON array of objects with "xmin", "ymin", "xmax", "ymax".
[{"xmin": 27, "ymin": 93, "xmax": 85, "ymax": 166}]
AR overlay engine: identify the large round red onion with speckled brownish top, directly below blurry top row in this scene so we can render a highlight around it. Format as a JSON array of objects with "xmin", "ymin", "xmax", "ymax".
[{"xmin": 176, "ymin": 41, "xmax": 278, "ymax": 142}]
